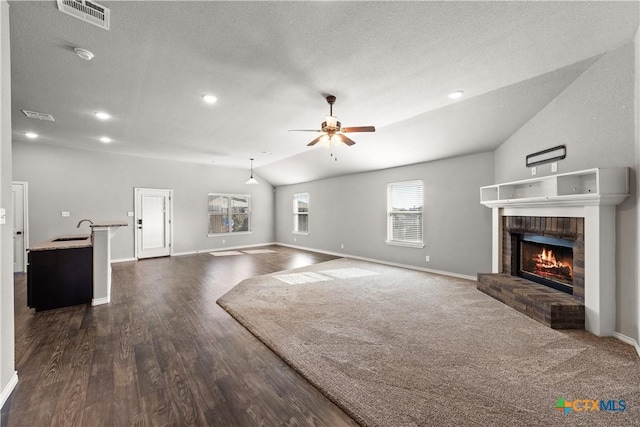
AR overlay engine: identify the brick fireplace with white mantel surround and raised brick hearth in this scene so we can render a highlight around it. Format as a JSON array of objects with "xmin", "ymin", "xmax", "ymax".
[{"xmin": 478, "ymin": 168, "xmax": 629, "ymax": 336}]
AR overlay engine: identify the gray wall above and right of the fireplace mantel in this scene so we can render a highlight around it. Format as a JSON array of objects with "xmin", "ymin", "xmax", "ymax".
[{"xmin": 495, "ymin": 42, "xmax": 639, "ymax": 340}]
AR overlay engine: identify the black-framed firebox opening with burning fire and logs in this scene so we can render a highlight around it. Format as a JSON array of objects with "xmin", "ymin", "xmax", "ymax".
[{"xmin": 518, "ymin": 234, "xmax": 573, "ymax": 294}]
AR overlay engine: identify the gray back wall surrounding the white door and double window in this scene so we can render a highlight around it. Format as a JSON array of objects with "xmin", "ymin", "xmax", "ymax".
[{"xmin": 13, "ymin": 142, "xmax": 274, "ymax": 260}]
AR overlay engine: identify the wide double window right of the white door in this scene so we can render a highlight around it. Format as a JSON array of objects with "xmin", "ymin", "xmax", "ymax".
[{"xmin": 208, "ymin": 193, "xmax": 251, "ymax": 236}]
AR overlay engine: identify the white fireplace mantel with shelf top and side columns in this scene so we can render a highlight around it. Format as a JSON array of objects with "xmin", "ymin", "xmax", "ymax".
[{"xmin": 480, "ymin": 168, "xmax": 629, "ymax": 336}]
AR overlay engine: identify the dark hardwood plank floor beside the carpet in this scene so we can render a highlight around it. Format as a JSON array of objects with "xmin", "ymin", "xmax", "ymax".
[{"xmin": 1, "ymin": 246, "xmax": 357, "ymax": 427}]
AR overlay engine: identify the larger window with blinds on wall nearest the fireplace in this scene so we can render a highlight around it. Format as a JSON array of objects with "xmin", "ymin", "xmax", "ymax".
[{"xmin": 387, "ymin": 181, "xmax": 424, "ymax": 248}]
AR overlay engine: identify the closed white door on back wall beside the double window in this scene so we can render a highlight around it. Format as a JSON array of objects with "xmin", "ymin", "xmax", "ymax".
[{"xmin": 135, "ymin": 188, "xmax": 172, "ymax": 258}]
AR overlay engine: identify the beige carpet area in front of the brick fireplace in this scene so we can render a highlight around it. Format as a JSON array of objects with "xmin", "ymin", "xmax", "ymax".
[{"xmin": 218, "ymin": 259, "xmax": 640, "ymax": 427}]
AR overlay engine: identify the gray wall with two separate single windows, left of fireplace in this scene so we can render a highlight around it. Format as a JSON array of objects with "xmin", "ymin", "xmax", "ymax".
[{"xmin": 276, "ymin": 153, "xmax": 493, "ymax": 276}]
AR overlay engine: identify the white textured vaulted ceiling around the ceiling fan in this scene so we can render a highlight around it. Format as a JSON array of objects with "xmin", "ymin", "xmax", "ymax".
[{"xmin": 10, "ymin": 1, "xmax": 639, "ymax": 185}]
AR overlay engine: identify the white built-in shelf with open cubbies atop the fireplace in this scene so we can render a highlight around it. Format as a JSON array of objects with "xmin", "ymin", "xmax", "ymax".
[{"xmin": 480, "ymin": 168, "xmax": 629, "ymax": 208}]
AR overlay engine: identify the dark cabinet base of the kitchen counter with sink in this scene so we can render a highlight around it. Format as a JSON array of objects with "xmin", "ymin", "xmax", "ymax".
[{"xmin": 27, "ymin": 247, "xmax": 93, "ymax": 311}]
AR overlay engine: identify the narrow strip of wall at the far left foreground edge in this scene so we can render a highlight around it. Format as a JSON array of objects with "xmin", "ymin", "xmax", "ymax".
[{"xmin": 0, "ymin": 0, "xmax": 15, "ymax": 408}]
